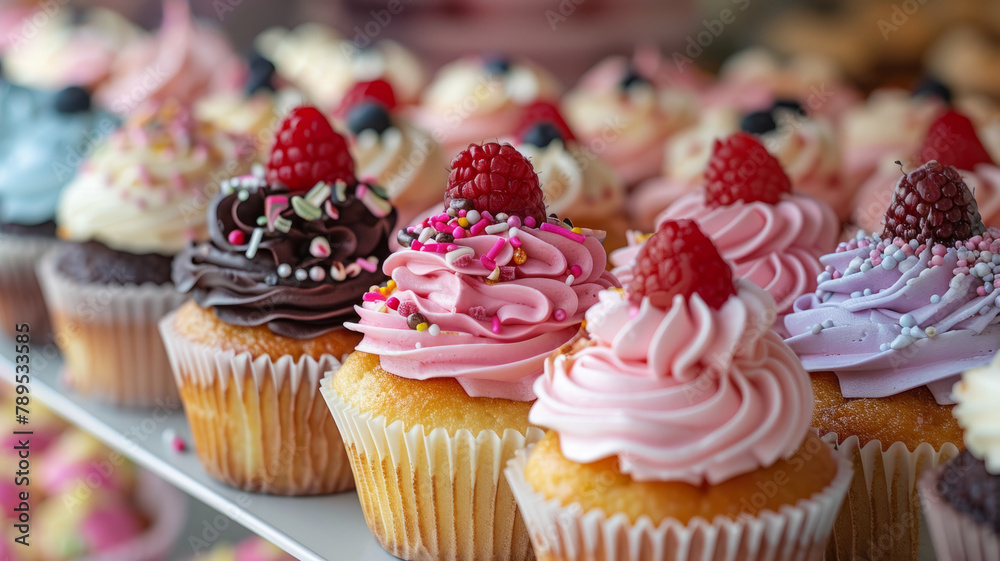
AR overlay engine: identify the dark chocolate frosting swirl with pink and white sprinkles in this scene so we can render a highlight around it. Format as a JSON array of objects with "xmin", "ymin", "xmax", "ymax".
[{"xmin": 173, "ymin": 171, "xmax": 396, "ymax": 339}]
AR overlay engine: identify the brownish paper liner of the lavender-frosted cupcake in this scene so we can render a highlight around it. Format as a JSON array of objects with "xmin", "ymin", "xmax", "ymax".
[{"xmin": 823, "ymin": 433, "xmax": 958, "ymax": 561}]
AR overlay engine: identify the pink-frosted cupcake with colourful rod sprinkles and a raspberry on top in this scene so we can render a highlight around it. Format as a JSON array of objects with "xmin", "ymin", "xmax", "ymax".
[{"xmin": 321, "ymin": 143, "xmax": 618, "ymax": 560}]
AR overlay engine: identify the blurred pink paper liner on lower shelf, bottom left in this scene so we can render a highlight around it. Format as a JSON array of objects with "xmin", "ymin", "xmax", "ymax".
[{"xmin": 77, "ymin": 470, "xmax": 187, "ymax": 561}]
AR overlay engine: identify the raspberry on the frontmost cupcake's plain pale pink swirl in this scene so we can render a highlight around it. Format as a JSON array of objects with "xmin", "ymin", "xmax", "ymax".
[{"xmin": 628, "ymin": 220, "xmax": 736, "ymax": 310}]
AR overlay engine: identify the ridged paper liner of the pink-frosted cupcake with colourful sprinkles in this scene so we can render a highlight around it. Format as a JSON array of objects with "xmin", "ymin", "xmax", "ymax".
[{"xmin": 321, "ymin": 372, "xmax": 544, "ymax": 561}]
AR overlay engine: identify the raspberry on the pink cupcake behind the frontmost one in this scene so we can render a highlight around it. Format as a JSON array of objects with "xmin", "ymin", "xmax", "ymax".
[{"xmin": 705, "ymin": 132, "xmax": 792, "ymax": 208}]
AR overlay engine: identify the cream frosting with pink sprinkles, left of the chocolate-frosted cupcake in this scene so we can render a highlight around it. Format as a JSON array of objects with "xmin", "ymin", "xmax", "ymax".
[{"xmin": 56, "ymin": 105, "xmax": 250, "ymax": 255}]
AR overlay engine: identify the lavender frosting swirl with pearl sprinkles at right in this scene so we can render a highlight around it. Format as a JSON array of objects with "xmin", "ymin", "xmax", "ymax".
[{"xmin": 785, "ymin": 228, "xmax": 1000, "ymax": 404}]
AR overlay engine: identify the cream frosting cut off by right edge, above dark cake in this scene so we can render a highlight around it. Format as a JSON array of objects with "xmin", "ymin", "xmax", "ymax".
[{"xmin": 952, "ymin": 355, "xmax": 1000, "ymax": 475}]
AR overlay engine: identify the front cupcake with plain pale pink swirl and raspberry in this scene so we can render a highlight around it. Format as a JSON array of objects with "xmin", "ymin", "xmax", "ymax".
[{"xmin": 505, "ymin": 220, "xmax": 851, "ymax": 561}]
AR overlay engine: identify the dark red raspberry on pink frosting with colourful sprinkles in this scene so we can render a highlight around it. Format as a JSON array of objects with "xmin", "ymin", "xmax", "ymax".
[{"xmin": 444, "ymin": 142, "xmax": 545, "ymax": 223}]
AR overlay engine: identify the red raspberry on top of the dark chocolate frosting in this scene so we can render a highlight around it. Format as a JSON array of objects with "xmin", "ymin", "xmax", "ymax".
[{"xmin": 267, "ymin": 106, "xmax": 355, "ymax": 191}]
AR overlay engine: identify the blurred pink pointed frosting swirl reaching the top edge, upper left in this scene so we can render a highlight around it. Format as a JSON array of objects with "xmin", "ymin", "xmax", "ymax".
[{"xmin": 96, "ymin": 0, "xmax": 245, "ymax": 116}]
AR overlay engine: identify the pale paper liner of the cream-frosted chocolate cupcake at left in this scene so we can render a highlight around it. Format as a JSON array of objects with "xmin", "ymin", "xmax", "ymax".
[{"xmin": 38, "ymin": 248, "xmax": 184, "ymax": 408}]
